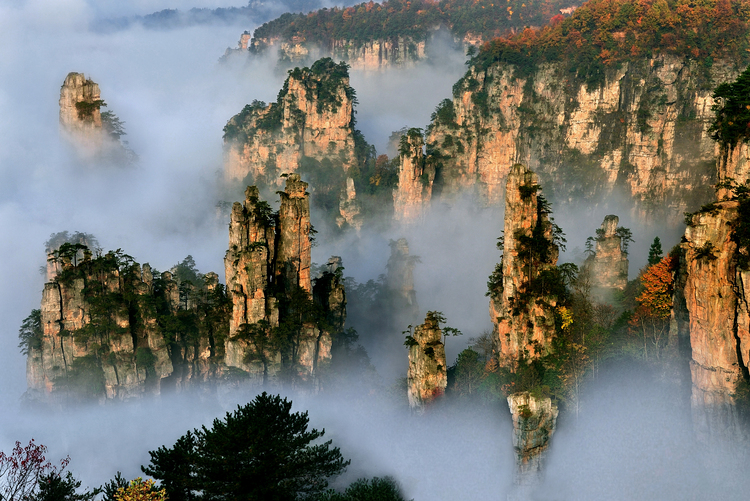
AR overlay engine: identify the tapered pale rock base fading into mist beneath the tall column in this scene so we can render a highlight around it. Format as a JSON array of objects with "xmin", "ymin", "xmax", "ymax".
[{"xmin": 508, "ymin": 392, "xmax": 558, "ymax": 485}]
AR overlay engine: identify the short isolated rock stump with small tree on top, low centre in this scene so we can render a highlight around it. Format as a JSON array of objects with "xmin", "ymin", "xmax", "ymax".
[{"xmin": 407, "ymin": 312, "xmax": 448, "ymax": 414}]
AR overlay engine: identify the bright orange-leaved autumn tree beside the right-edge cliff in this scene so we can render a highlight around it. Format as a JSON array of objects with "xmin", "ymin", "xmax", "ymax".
[{"xmin": 630, "ymin": 256, "xmax": 676, "ymax": 359}]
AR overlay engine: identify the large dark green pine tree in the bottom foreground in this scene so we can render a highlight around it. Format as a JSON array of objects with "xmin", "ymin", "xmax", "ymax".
[{"xmin": 142, "ymin": 392, "xmax": 349, "ymax": 501}]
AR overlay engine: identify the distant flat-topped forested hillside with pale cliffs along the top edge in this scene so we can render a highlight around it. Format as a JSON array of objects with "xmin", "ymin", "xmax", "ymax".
[{"xmin": 240, "ymin": 0, "xmax": 579, "ymax": 63}]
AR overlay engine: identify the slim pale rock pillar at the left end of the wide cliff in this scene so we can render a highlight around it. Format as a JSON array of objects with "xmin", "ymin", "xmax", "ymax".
[{"xmin": 393, "ymin": 129, "xmax": 435, "ymax": 223}]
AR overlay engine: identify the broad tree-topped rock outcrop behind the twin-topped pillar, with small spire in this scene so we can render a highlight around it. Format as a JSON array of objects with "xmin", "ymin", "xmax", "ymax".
[{"xmin": 224, "ymin": 59, "xmax": 361, "ymax": 228}]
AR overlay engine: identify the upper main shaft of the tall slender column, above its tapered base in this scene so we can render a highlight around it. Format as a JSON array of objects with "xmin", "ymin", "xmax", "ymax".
[{"xmin": 490, "ymin": 164, "xmax": 558, "ymax": 367}]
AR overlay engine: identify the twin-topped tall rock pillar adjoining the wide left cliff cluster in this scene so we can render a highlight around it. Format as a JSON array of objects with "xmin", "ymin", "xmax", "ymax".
[{"xmin": 224, "ymin": 174, "xmax": 346, "ymax": 384}]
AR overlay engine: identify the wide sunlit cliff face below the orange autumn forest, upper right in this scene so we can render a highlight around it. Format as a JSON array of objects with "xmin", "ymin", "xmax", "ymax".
[{"xmin": 397, "ymin": 55, "xmax": 734, "ymax": 222}]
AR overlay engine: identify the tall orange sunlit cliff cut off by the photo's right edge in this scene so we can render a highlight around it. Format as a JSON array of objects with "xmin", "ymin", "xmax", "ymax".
[{"xmin": 683, "ymin": 144, "xmax": 750, "ymax": 442}]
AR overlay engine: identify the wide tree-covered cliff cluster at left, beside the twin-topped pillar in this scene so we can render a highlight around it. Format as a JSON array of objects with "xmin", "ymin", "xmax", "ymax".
[{"xmin": 27, "ymin": 254, "xmax": 227, "ymax": 402}]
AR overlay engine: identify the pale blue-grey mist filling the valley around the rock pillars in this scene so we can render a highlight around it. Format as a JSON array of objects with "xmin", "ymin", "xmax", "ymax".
[{"xmin": 0, "ymin": 0, "xmax": 750, "ymax": 500}]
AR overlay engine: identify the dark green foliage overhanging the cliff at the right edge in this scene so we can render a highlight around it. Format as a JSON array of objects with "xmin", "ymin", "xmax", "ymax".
[{"xmin": 708, "ymin": 64, "xmax": 750, "ymax": 148}]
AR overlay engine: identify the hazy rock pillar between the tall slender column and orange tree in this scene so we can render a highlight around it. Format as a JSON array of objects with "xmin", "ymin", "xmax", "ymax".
[{"xmin": 584, "ymin": 215, "xmax": 628, "ymax": 290}]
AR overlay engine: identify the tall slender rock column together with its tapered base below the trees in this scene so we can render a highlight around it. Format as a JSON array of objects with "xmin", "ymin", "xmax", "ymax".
[{"xmin": 490, "ymin": 164, "xmax": 559, "ymax": 485}]
